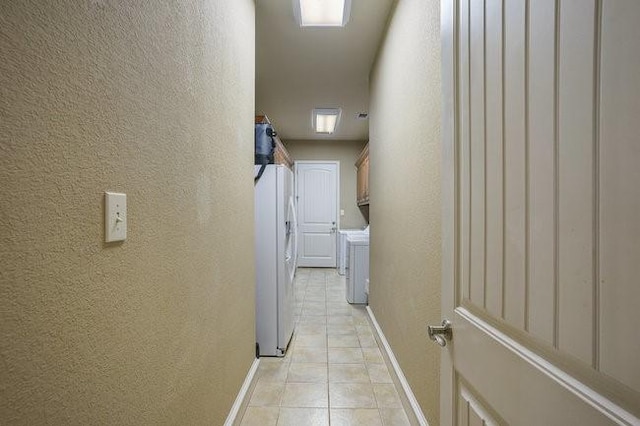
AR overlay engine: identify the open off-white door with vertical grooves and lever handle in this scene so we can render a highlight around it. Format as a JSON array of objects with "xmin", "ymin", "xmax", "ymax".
[{"xmin": 441, "ymin": 0, "xmax": 640, "ymax": 426}]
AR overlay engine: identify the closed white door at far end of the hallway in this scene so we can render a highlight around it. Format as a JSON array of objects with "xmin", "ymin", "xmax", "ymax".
[{"xmin": 296, "ymin": 161, "xmax": 339, "ymax": 268}]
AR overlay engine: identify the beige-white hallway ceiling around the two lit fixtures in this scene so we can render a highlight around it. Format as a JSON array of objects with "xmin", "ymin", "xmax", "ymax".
[{"xmin": 256, "ymin": 0, "xmax": 393, "ymax": 140}]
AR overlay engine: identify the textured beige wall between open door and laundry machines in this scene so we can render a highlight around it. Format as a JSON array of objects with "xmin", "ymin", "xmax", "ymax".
[{"xmin": 369, "ymin": 0, "xmax": 441, "ymax": 425}]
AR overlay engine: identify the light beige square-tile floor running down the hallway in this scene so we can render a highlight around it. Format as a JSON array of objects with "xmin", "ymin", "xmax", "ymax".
[{"xmin": 241, "ymin": 268, "xmax": 409, "ymax": 426}]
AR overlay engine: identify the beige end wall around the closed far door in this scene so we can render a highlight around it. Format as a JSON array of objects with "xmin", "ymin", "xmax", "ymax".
[{"xmin": 284, "ymin": 140, "xmax": 367, "ymax": 229}]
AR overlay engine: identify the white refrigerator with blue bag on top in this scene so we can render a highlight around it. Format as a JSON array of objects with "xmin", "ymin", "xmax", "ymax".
[{"xmin": 255, "ymin": 164, "xmax": 298, "ymax": 356}]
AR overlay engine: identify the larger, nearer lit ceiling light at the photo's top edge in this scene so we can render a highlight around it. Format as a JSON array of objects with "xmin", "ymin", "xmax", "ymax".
[{"xmin": 293, "ymin": 0, "xmax": 351, "ymax": 27}]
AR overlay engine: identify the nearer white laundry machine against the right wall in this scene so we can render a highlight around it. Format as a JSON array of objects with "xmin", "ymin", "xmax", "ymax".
[{"xmin": 346, "ymin": 234, "xmax": 369, "ymax": 303}]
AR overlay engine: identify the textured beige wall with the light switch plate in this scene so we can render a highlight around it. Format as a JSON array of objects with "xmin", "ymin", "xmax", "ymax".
[{"xmin": 0, "ymin": 0, "xmax": 255, "ymax": 425}]
